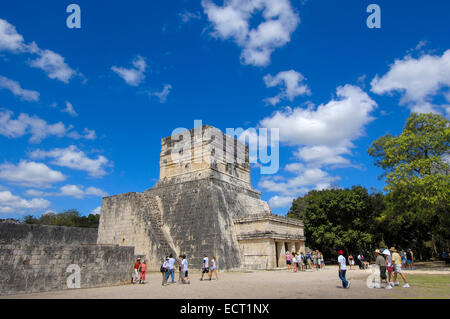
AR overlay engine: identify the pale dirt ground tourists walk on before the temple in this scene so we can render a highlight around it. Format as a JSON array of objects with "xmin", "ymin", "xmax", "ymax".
[{"xmin": 3, "ymin": 266, "xmax": 450, "ymax": 299}]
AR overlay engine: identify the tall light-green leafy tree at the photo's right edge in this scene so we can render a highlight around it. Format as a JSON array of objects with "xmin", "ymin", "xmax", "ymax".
[{"xmin": 368, "ymin": 113, "xmax": 450, "ymax": 255}]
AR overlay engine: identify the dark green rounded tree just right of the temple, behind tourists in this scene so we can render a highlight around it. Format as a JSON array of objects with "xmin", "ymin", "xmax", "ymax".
[{"xmin": 288, "ymin": 186, "xmax": 383, "ymax": 255}]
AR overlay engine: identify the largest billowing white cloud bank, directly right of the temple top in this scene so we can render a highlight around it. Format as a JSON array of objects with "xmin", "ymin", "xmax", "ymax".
[{"xmin": 258, "ymin": 84, "xmax": 377, "ymax": 201}]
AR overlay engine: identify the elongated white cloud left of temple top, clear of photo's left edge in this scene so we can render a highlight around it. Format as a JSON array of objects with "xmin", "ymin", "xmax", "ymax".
[{"xmin": 30, "ymin": 145, "xmax": 112, "ymax": 177}]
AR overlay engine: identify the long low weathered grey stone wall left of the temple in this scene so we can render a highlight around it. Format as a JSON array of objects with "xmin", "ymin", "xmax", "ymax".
[{"xmin": 0, "ymin": 223, "xmax": 135, "ymax": 295}]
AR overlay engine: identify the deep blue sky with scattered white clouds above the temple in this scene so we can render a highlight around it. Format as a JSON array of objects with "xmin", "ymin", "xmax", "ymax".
[{"xmin": 0, "ymin": 0, "xmax": 450, "ymax": 218}]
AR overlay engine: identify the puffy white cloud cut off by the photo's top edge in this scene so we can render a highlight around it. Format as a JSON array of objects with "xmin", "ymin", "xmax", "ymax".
[{"xmin": 202, "ymin": 0, "xmax": 300, "ymax": 66}]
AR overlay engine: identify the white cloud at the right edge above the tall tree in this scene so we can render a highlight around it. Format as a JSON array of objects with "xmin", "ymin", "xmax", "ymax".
[{"xmin": 371, "ymin": 50, "xmax": 450, "ymax": 113}]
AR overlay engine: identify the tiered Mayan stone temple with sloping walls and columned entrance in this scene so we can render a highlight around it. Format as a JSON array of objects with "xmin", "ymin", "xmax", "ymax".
[{"xmin": 97, "ymin": 125, "xmax": 305, "ymax": 270}]
